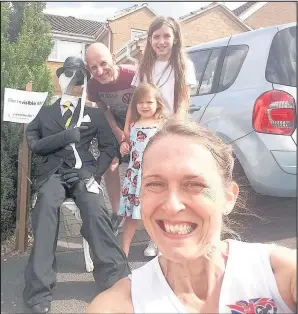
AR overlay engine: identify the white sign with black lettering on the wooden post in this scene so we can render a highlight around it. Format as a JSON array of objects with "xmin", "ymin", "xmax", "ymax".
[{"xmin": 3, "ymin": 88, "xmax": 48, "ymax": 123}]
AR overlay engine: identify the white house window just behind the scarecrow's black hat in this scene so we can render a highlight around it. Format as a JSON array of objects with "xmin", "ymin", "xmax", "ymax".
[{"xmin": 48, "ymin": 39, "xmax": 89, "ymax": 62}]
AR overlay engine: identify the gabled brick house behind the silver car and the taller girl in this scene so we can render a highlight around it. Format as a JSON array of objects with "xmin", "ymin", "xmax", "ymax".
[{"xmin": 116, "ymin": 2, "xmax": 297, "ymax": 64}]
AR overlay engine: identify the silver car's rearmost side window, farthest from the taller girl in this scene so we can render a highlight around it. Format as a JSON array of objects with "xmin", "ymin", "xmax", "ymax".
[{"xmin": 218, "ymin": 45, "xmax": 248, "ymax": 92}]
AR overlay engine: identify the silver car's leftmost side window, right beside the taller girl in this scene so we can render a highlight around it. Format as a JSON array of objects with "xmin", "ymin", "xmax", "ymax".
[{"xmin": 189, "ymin": 49, "xmax": 211, "ymax": 96}]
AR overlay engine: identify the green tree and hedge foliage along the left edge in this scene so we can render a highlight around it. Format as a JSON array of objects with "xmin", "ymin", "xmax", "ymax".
[{"xmin": 1, "ymin": 2, "xmax": 53, "ymax": 240}]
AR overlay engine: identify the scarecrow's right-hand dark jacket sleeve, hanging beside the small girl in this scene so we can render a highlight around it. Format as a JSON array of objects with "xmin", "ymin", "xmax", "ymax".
[{"xmin": 96, "ymin": 110, "xmax": 116, "ymax": 177}]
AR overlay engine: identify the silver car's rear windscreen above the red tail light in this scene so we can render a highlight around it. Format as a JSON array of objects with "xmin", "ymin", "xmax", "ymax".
[{"xmin": 265, "ymin": 26, "xmax": 297, "ymax": 86}]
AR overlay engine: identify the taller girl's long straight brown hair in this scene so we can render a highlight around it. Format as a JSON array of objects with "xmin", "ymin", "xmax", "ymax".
[{"xmin": 139, "ymin": 16, "xmax": 188, "ymax": 112}]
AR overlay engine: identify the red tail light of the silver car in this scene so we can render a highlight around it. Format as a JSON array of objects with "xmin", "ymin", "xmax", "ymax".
[{"xmin": 252, "ymin": 90, "xmax": 296, "ymax": 135}]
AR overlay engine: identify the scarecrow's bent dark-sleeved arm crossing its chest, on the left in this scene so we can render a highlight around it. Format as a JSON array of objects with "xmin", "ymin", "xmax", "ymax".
[{"xmin": 26, "ymin": 114, "xmax": 79, "ymax": 155}]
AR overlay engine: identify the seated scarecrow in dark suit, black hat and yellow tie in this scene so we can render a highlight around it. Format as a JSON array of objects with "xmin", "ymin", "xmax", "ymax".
[{"xmin": 23, "ymin": 57, "xmax": 130, "ymax": 313}]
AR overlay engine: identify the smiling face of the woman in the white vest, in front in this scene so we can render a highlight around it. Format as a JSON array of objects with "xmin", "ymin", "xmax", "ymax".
[{"xmin": 141, "ymin": 135, "xmax": 238, "ymax": 262}]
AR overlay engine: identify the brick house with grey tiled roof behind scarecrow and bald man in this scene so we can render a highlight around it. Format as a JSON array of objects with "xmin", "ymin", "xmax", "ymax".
[{"xmin": 45, "ymin": 3, "xmax": 156, "ymax": 95}]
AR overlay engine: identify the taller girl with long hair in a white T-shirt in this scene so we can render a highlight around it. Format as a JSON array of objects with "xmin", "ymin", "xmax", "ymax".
[{"xmin": 124, "ymin": 16, "xmax": 196, "ymax": 256}]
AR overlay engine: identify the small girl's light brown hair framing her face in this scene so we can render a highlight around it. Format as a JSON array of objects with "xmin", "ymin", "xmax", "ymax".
[{"xmin": 130, "ymin": 83, "xmax": 165, "ymax": 121}]
